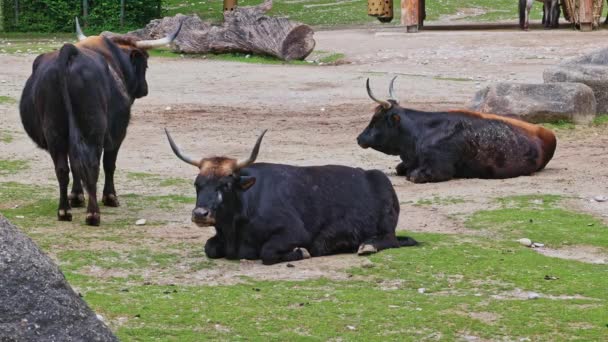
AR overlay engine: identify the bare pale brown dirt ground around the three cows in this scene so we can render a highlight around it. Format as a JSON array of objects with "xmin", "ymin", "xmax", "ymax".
[{"xmin": 0, "ymin": 29, "xmax": 608, "ymax": 283}]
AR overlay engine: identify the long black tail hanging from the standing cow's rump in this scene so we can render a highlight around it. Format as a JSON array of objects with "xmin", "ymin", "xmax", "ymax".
[{"xmin": 57, "ymin": 44, "xmax": 98, "ymax": 191}]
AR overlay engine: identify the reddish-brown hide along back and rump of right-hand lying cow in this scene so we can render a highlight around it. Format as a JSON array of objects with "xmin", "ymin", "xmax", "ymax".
[{"xmin": 448, "ymin": 109, "xmax": 557, "ymax": 168}]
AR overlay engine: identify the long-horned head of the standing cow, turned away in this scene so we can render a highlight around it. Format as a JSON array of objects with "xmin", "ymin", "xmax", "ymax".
[{"xmin": 76, "ymin": 18, "xmax": 182, "ymax": 99}]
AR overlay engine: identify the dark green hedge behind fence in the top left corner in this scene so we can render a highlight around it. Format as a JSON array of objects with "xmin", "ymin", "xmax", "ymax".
[{"xmin": 0, "ymin": 0, "xmax": 162, "ymax": 32}]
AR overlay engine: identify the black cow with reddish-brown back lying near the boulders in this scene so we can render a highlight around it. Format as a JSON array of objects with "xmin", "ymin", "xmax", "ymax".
[{"xmin": 357, "ymin": 78, "xmax": 556, "ymax": 183}]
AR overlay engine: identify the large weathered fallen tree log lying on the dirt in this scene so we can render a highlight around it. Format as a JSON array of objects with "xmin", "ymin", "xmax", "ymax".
[{"xmin": 128, "ymin": 0, "xmax": 315, "ymax": 61}]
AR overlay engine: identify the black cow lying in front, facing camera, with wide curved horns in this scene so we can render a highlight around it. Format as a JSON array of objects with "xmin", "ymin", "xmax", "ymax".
[{"xmin": 167, "ymin": 131, "xmax": 416, "ymax": 265}]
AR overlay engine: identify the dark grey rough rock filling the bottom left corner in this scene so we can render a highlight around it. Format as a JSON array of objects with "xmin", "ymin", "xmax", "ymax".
[{"xmin": 0, "ymin": 215, "xmax": 117, "ymax": 342}]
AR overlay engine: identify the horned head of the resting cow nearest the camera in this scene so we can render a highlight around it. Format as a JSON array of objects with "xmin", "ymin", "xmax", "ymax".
[{"xmin": 165, "ymin": 129, "xmax": 266, "ymax": 227}]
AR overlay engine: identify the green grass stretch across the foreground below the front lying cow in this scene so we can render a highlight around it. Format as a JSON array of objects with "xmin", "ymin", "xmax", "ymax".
[{"xmin": 67, "ymin": 234, "xmax": 608, "ymax": 341}]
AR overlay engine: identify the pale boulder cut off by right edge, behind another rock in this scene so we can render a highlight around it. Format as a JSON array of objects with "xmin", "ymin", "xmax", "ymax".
[{"xmin": 543, "ymin": 49, "xmax": 608, "ymax": 113}]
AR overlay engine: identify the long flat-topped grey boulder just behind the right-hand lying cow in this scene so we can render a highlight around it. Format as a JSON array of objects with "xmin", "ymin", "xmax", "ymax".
[{"xmin": 469, "ymin": 82, "xmax": 596, "ymax": 123}]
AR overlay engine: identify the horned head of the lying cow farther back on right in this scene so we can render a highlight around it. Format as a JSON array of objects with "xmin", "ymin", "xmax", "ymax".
[{"xmin": 357, "ymin": 76, "xmax": 402, "ymax": 155}]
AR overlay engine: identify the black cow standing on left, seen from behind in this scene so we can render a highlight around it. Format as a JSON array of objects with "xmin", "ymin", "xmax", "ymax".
[{"xmin": 20, "ymin": 20, "xmax": 181, "ymax": 226}]
